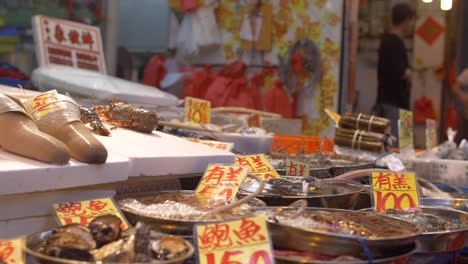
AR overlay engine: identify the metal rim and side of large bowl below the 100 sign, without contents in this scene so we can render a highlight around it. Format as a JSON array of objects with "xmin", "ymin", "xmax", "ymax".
[{"xmin": 259, "ymin": 207, "xmax": 421, "ymax": 258}]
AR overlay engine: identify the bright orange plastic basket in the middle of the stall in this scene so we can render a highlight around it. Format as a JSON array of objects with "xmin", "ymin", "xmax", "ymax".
[{"xmin": 272, "ymin": 135, "xmax": 335, "ymax": 154}]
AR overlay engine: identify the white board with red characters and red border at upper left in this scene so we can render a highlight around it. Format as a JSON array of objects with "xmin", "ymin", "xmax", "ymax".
[{"xmin": 33, "ymin": 16, "xmax": 106, "ymax": 74}]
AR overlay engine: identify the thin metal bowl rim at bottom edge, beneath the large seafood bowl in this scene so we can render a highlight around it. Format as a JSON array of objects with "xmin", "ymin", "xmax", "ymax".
[{"xmin": 275, "ymin": 243, "xmax": 417, "ymax": 264}]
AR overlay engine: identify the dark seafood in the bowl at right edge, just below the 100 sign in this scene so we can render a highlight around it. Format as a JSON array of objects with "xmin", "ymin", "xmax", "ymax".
[{"xmin": 385, "ymin": 210, "xmax": 468, "ymax": 233}]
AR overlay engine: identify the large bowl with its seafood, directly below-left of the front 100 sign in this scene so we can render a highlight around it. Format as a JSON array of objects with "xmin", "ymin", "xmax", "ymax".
[{"xmin": 256, "ymin": 207, "xmax": 421, "ymax": 258}]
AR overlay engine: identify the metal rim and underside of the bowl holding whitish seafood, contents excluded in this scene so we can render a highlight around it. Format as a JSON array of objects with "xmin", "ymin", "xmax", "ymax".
[{"xmin": 116, "ymin": 191, "xmax": 265, "ymax": 236}]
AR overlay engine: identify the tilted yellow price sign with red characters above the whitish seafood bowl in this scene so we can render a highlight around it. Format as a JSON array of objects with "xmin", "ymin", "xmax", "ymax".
[{"xmin": 195, "ymin": 164, "xmax": 249, "ymax": 200}]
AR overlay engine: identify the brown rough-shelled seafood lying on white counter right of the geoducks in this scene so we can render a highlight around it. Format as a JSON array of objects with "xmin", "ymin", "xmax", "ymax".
[{"xmin": 93, "ymin": 99, "xmax": 159, "ymax": 133}]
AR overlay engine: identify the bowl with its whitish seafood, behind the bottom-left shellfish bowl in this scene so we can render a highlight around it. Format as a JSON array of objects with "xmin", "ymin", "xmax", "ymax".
[{"xmin": 118, "ymin": 191, "xmax": 265, "ymax": 235}]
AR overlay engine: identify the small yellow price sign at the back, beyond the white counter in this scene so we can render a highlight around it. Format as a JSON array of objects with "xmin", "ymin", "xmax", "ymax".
[{"xmin": 185, "ymin": 97, "xmax": 211, "ymax": 125}]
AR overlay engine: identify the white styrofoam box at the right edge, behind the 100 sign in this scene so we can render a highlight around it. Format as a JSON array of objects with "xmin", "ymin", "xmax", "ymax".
[{"xmin": 403, "ymin": 158, "xmax": 468, "ymax": 186}]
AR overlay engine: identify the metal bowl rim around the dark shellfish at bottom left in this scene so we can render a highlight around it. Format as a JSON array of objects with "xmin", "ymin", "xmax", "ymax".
[{"xmin": 24, "ymin": 230, "xmax": 195, "ymax": 264}]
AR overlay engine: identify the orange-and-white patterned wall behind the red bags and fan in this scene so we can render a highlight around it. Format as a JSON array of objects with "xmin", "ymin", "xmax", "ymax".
[{"xmin": 193, "ymin": 0, "xmax": 344, "ymax": 135}]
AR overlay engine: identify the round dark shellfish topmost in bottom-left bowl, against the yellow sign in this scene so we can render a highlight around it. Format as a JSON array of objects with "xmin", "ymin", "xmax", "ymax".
[{"xmin": 88, "ymin": 215, "xmax": 122, "ymax": 248}]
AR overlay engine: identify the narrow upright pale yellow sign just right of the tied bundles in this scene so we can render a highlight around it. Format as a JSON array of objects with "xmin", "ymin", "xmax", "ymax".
[{"xmin": 398, "ymin": 109, "xmax": 414, "ymax": 156}]
